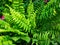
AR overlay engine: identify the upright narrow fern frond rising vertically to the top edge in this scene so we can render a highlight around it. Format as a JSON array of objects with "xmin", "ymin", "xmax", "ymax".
[{"xmin": 27, "ymin": 0, "xmax": 36, "ymax": 28}]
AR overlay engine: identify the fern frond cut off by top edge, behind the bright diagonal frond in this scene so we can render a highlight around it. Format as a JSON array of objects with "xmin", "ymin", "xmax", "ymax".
[{"xmin": 12, "ymin": 0, "xmax": 25, "ymax": 14}]
